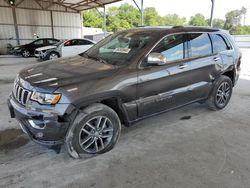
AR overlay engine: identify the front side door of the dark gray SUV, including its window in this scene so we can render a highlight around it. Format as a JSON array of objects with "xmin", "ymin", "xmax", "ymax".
[{"xmin": 137, "ymin": 34, "xmax": 192, "ymax": 117}]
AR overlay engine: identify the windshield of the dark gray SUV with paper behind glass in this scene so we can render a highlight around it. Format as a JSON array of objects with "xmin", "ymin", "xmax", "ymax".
[{"xmin": 80, "ymin": 31, "xmax": 152, "ymax": 66}]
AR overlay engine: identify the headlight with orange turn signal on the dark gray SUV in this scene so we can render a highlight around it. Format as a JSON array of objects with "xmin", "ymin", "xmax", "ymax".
[{"xmin": 31, "ymin": 91, "xmax": 61, "ymax": 104}]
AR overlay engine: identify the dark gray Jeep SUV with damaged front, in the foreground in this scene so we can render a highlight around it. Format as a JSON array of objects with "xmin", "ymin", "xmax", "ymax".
[{"xmin": 8, "ymin": 27, "xmax": 241, "ymax": 158}]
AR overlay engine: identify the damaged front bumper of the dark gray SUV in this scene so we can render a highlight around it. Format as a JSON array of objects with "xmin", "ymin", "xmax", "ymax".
[{"xmin": 8, "ymin": 95, "xmax": 72, "ymax": 146}]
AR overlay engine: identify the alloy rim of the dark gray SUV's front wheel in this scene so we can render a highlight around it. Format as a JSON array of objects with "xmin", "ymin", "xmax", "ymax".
[{"xmin": 79, "ymin": 116, "xmax": 114, "ymax": 154}]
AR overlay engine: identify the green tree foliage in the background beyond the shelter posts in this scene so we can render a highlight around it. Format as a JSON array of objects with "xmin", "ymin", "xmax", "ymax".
[{"xmin": 83, "ymin": 3, "xmax": 250, "ymax": 34}]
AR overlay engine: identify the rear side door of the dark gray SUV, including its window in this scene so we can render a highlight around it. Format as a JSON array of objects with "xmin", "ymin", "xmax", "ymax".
[{"xmin": 188, "ymin": 33, "xmax": 223, "ymax": 100}]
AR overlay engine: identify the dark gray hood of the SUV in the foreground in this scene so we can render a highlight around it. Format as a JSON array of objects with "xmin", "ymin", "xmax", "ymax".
[{"xmin": 19, "ymin": 55, "xmax": 118, "ymax": 92}]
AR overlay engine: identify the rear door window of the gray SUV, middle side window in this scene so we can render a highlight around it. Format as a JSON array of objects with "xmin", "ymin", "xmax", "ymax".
[{"xmin": 189, "ymin": 33, "xmax": 212, "ymax": 57}]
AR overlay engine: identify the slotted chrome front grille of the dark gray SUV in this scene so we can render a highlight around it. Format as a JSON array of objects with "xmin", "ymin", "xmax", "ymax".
[{"xmin": 13, "ymin": 84, "xmax": 31, "ymax": 105}]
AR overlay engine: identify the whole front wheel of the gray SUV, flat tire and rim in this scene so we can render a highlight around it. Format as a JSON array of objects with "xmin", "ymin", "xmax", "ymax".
[{"xmin": 65, "ymin": 103, "xmax": 121, "ymax": 158}]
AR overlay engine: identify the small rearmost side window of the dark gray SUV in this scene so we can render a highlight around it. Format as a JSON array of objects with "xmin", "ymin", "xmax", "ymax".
[{"xmin": 210, "ymin": 34, "xmax": 230, "ymax": 53}]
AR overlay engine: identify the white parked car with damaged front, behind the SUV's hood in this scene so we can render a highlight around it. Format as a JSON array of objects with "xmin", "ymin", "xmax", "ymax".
[{"xmin": 35, "ymin": 39, "xmax": 95, "ymax": 61}]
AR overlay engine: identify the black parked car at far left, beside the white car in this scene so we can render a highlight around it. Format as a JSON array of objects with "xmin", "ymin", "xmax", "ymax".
[{"xmin": 13, "ymin": 38, "xmax": 60, "ymax": 57}]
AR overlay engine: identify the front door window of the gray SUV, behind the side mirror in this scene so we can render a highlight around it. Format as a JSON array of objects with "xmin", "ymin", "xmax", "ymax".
[{"xmin": 152, "ymin": 34, "xmax": 185, "ymax": 61}]
